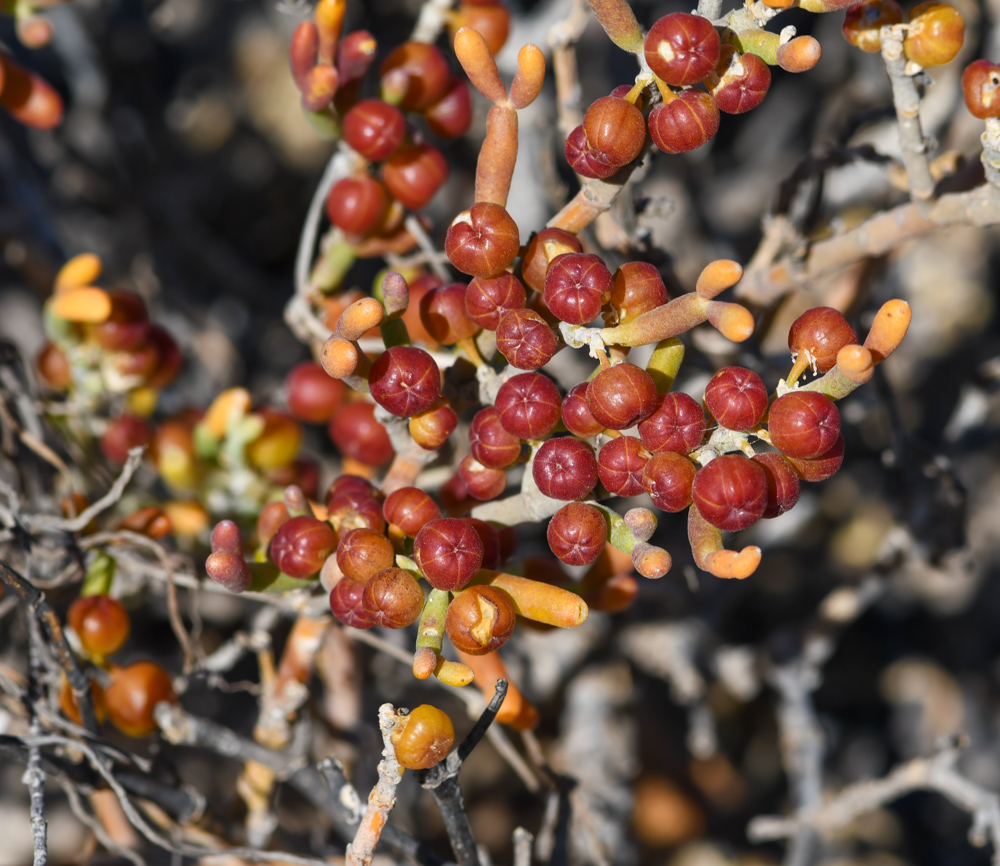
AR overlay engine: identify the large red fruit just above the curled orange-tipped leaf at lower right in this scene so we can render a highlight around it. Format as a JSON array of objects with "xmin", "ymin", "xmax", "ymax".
[{"xmin": 691, "ymin": 454, "xmax": 767, "ymax": 532}]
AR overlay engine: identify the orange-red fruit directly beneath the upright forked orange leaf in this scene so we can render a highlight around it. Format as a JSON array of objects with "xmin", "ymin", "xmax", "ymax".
[{"xmin": 444, "ymin": 201, "xmax": 521, "ymax": 277}]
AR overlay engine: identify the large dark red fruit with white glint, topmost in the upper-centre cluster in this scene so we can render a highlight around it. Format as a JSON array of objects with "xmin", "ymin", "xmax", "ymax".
[{"xmin": 644, "ymin": 12, "xmax": 720, "ymax": 87}]
